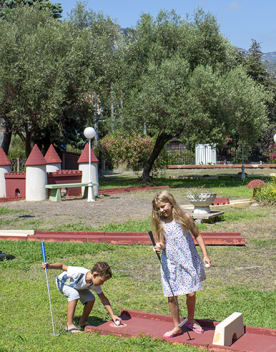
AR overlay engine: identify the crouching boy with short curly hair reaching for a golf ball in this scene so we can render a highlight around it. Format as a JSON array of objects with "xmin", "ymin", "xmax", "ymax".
[{"xmin": 42, "ymin": 262, "xmax": 121, "ymax": 333}]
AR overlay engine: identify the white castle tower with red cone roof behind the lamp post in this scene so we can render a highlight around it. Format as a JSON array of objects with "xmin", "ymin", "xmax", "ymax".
[{"xmin": 78, "ymin": 143, "xmax": 99, "ymax": 197}]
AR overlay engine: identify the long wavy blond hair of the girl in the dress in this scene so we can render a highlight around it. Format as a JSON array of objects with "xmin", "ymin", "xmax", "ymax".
[{"xmin": 152, "ymin": 191, "xmax": 190, "ymax": 243}]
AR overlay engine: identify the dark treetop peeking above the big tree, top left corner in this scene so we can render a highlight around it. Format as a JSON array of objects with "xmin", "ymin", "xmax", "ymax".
[{"xmin": 0, "ymin": 0, "xmax": 62, "ymax": 19}]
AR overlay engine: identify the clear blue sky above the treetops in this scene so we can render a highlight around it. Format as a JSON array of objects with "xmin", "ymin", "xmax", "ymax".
[{"xmin": 56, "ymin": 0, "xmax": 276, "ymax": 53}]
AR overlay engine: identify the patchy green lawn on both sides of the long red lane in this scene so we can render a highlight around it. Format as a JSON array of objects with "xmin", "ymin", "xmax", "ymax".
[{"xmin": 0, "ymin": 178, "xmax": 276, "ymax": 352}]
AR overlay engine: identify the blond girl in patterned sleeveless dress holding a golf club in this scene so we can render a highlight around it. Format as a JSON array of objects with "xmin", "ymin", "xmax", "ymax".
[{"xmin": 152, "ymin": 191, "xmax": 211, "ymax": 338}]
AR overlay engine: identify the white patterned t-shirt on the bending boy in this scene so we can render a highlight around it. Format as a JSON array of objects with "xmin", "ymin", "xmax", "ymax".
[{"xmin": 57, "ymin": 266, "xmax": 103, "ymax": 294}]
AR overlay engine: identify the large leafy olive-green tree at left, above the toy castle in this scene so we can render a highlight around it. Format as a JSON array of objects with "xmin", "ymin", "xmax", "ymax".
[{"xmin": 0, "ymin": 6, "xmax": 97, "ymax": 155}]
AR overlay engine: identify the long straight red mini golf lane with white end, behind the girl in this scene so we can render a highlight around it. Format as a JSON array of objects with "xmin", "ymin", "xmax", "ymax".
[{"xmin": 0, "ymin": 230, "xmax": 245, "ymax": 246}]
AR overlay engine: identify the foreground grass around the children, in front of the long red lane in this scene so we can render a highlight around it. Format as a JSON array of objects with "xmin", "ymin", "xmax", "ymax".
[{"xmin": 0, "ymin": 236, "xmax": 276, "ymax": 352}]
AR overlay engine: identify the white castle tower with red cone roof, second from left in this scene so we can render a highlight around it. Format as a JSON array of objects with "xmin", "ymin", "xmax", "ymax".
[{"xmin": 25, "ymin": 144, "xmax": 47, "ymax": 201}]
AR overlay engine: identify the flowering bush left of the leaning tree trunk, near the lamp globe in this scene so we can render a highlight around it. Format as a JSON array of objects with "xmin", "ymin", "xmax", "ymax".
[{"xmin": 100, "ymin": 132, "xmax": 153, "ymax": 171}]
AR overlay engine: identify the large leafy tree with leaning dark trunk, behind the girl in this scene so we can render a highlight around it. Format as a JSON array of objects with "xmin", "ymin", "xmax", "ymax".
[{"xmin": 119, "ymin": 10, "xmax": 268, "ymax": 181}]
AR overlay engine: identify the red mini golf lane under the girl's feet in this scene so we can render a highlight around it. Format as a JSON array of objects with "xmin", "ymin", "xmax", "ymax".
[{"xmin": 85, "ymin": 310, "xmax": 276, "ymax": 352}]
